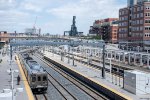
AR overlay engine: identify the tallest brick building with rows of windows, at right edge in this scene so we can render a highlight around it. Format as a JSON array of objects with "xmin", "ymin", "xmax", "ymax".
[{"xmin": 118, "ymin": 0, "xmax": 150, "ymax": 50}]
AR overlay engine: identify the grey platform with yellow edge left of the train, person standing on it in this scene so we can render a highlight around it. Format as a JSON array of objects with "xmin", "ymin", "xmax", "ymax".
[{"xmin": 0, "ymin": 50, "xmax": 34, "ymax": 100}]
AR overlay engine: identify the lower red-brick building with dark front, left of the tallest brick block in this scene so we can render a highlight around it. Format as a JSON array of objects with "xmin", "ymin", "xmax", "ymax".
[{"xmin": 89, "ymin": 18, "xmax": 118, "ymax": 43}]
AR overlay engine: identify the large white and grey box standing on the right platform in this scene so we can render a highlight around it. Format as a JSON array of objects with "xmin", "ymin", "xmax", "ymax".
[{"xmin": 124, "ymin": 70, "xmax": 150, "ymax": 95}]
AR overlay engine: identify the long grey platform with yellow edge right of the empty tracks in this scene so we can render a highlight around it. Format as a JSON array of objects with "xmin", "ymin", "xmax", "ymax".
[{"xmin": 44, "ymin": 51, "xmax": 150, "ymax": 100}]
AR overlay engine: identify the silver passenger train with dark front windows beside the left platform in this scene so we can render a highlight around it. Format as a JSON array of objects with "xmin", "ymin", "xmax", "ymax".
[{"xmin": 19, "ymin": 53, "xmax": 48, "ymax": 93}]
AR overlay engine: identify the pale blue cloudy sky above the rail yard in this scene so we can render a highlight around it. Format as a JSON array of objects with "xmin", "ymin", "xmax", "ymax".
[{"xmin": 0, "ymin": 0, "xmax": 127, "ymax": 35}]
